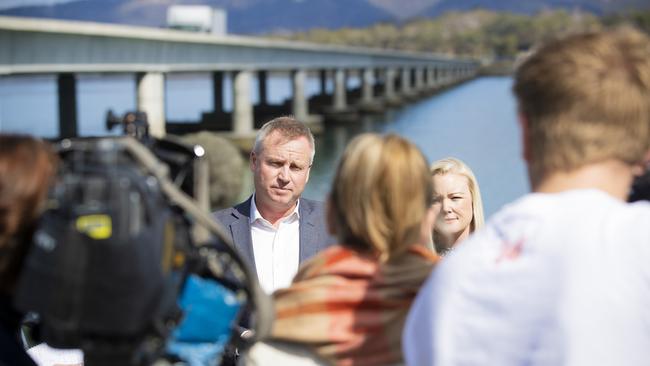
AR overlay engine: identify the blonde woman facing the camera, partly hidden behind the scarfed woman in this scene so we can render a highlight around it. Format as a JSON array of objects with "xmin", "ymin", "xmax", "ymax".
[{"xmin": 431, "ymin": 158, "xmax": 484, "ymax": 254}]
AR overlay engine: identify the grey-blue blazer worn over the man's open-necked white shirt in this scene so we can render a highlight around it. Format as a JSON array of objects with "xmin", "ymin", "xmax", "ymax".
[{"xmin": 214, "ymin": 196, "xmax": 335, "ymax": 273}]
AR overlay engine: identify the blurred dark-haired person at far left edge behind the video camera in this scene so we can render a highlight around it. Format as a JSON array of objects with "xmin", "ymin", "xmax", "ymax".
[{"xmin": 0, "ymin": 134, "xmax": 56, "ymax": 366}]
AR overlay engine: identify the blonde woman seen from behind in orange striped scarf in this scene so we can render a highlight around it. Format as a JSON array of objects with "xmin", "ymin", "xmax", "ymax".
[{"xmin": 249, "ymin": 134, "xmax": 438, "ymax": 366}]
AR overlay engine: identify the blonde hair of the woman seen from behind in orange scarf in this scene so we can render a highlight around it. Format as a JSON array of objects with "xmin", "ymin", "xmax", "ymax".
[{"xmin": 328, "ymin": 134, "xmax": 433, "ymax": 261}]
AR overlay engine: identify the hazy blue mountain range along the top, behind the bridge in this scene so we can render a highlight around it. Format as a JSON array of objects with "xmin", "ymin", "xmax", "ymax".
[{"xmin": 0, "ymin": 0, "xmax": 650, "ymax": 34}]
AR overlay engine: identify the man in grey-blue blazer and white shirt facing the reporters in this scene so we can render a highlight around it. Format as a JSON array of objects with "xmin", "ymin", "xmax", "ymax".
[{"xmin": 214, "ymin": 117, "xmax": 334, "ymax": 293}]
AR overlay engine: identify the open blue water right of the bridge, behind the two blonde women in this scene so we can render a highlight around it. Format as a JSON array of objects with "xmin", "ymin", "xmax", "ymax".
[{"xmin": 305, "ymin": 77, "xmax": 529, "ymax": 217}]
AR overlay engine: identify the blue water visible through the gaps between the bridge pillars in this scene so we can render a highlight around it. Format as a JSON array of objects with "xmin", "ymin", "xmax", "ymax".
[{"xmin": 0, "ymin": 72, "xmax": 354, "ymax": 129}]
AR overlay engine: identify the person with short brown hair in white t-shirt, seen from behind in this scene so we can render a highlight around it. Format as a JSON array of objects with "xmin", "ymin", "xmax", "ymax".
[{"xmin": 402, "ymin": 28, "xmax": 650, "ymax": 366}]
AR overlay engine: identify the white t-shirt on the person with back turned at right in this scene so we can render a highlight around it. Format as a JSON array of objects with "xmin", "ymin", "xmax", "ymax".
[{"xmin": 403, "ymin": 190, "xmax": 650, "ymax": 366}]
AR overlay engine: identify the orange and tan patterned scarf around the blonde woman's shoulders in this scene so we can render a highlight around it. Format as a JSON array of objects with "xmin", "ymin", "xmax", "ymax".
[{"xmin": 272, "ymin": 246, "xmax": 438, "ymax": 365}]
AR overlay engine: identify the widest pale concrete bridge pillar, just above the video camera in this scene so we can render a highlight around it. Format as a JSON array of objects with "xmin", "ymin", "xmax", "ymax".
[{"xmin": 137, "ymin": 72, "xmax": 165, "ymax": 137}]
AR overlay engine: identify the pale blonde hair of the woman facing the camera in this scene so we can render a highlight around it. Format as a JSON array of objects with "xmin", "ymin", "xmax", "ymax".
[{"xmin": 431, "ymin": 158, "xmax": 485, "ymax": 233}]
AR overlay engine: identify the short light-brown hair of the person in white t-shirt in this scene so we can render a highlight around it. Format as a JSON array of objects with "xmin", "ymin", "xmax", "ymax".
[{"xmin": 514, "ymin": 27, "xmax": 650, "ymax": 183}]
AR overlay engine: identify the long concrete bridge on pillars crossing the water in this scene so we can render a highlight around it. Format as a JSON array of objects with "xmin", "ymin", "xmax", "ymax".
[{"xmin": 0, "ymin": 17, "xmax": 478, "ymax": 137}]
